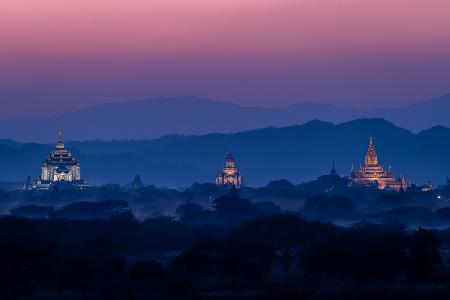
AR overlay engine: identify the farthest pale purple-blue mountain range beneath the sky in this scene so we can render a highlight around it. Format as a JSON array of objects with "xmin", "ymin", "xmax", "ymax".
[{"xmin": 0, "ymin": 94, "xmax": 450, "ymax": 143}]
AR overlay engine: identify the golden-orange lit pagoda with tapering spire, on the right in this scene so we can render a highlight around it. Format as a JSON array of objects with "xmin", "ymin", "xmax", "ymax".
[{"xmin": 350, "ymin": 136, "xmax": 409, "ymax": 191}]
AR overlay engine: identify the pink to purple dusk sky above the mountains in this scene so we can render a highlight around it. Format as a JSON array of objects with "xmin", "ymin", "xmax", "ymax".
[{"xmin": 0, "ymin": 0, "xmax": 450, "ymax": 120}]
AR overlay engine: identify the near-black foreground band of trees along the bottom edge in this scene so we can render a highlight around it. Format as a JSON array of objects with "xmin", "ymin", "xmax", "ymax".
[{"xmin": 0, "ymin": 213, "xmax": 450, "ymax": 299}]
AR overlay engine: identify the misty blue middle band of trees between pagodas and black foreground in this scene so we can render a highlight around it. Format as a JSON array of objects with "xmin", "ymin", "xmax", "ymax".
[{"xmin": 0, "ymin": 175, "xmax": 450, "ymax": 228}]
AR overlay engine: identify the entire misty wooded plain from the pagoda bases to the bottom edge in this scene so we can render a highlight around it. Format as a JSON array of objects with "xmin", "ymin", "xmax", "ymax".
[{"xmin": 0, "ymin": 175, "xmax": 450, "ymax": 300}]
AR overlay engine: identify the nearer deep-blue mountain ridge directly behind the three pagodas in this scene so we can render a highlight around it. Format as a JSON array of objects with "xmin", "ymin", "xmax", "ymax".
[{"xmin": 0, "ymin": 118, "xmax": 450, "ymax": 187}]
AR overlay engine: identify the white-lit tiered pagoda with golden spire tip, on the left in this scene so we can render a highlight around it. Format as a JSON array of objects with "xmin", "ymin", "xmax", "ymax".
[{"xmin": 32, "ymin": 129, "xmax": 88, "ymax": 189}]
